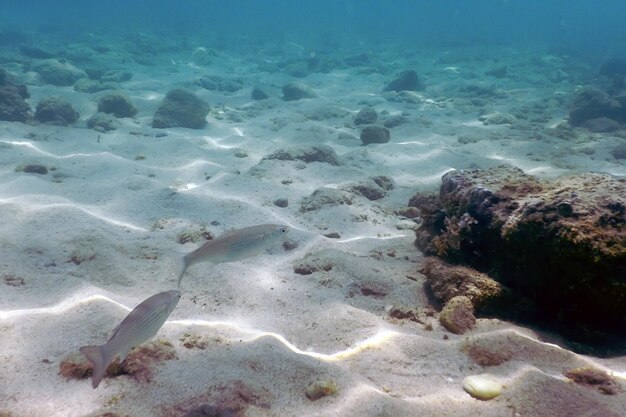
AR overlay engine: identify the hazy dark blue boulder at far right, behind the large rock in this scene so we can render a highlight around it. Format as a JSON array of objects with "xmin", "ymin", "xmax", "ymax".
[{"xmin": 569, "ymin": 87, "xmax": 624, "ymax": 126}]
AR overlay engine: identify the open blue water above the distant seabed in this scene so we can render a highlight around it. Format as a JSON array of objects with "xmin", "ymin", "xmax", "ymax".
[{"xmin": 0, "ymin": 0, "xmax": 626, "ymax": 56}]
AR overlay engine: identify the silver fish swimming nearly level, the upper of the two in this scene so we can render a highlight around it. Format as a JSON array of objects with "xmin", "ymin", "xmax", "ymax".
[{"xmin": 176, "ymin": 224, "xmax": 289, "ymax": 287}]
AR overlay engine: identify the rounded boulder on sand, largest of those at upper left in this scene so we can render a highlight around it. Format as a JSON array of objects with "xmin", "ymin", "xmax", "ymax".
[{"xmin": 152, "ymin": 88, "xmax": 209, "ymax": 129}]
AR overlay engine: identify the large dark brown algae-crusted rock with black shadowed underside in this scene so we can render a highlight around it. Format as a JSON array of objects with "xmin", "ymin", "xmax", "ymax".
[{"xmin": 410, "ymin": 167, "xmax": 626, "ymax": 346}]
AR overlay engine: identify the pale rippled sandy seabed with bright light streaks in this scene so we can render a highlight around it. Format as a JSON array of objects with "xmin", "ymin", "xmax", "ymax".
[{"xmin": 0, "ymin": 43, "xmax": 626, "ymax": 417}]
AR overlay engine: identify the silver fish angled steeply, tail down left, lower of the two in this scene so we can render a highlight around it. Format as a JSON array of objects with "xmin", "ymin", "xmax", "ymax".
[{"xmin": 80, "ymin": 290, "xmax": 180, "ymax": 388}]
